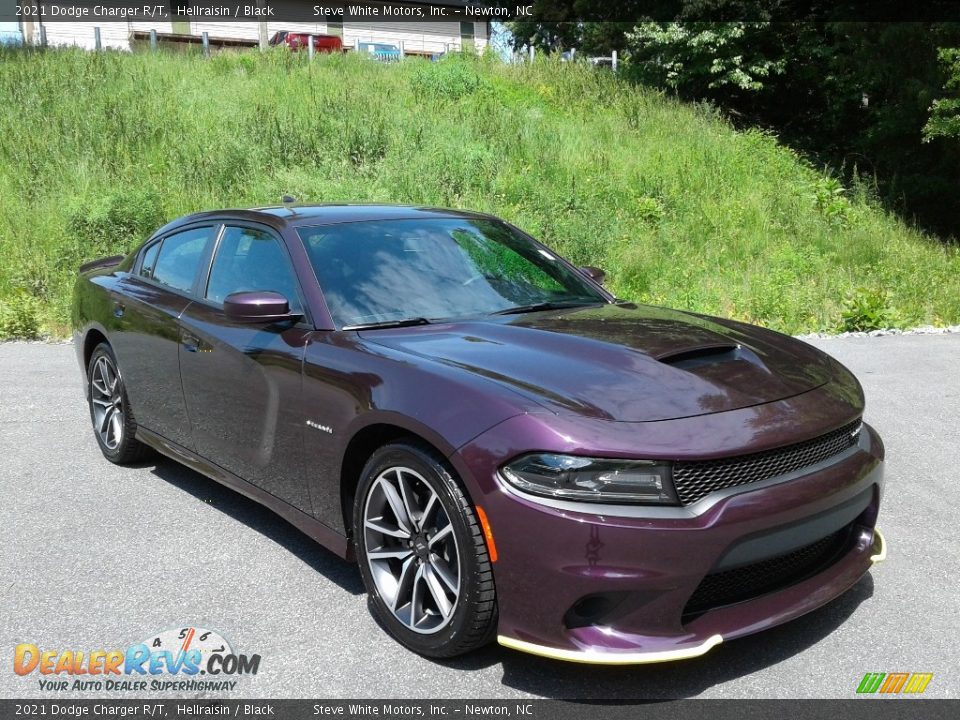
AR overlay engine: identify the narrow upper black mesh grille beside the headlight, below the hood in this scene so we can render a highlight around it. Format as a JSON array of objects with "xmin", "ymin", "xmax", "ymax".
[{"xmin": 673, "ymin": 420, "xmax": 862, "ymax": 505}]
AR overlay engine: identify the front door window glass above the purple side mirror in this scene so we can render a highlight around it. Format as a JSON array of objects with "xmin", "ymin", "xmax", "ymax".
[{"xmin": 206, "ymin": 226, "xmax": 301, "ymax": 312}]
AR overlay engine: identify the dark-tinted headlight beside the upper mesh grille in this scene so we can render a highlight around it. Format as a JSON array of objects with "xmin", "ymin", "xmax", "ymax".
[{"xmin": 502, "ymin": 453, "xmax": 679, "ymax": 505}]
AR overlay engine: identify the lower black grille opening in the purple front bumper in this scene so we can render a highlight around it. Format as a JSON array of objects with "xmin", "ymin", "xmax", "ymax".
[{"xmin": 683, "ymin": 525, "xmax": 850, "ymax": 619}]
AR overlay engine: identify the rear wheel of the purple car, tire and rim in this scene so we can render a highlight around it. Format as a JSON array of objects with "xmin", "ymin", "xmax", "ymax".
[{"xmin": 87, "ymin": 343, "xmax": 149, "ymax": 465}]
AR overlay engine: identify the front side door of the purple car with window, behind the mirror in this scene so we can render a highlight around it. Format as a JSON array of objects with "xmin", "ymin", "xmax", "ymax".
[{"xmin": 180, "ymin": 223, "xmax": 311, "ymax": 513}]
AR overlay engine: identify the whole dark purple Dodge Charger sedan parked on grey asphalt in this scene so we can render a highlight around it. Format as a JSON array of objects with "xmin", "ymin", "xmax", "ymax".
[{"xmin": 73, "ymin": 205, "xmax": 886, "ymax": 663}]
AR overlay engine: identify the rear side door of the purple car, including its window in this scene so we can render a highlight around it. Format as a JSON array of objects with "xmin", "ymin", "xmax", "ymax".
[{"xmin": 111, "ymin": 225, "xmax": 216, "ymax": 449}]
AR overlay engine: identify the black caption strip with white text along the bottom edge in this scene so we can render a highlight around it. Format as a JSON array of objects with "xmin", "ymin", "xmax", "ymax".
[{"xmin": 0, "ymin": 697, "xmax": 960, "ymax": 720}]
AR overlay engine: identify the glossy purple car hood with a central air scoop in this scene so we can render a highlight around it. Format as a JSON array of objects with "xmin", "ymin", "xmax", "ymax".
[{"xmin": 361, "ymin": 304, "xmax": 843, "ymax": 422}]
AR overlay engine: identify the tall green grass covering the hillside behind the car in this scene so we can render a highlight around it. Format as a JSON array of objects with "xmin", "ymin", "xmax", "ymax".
[{"xmin": 0, "ymin": 50, "xmax": 960, "ymax": 337}]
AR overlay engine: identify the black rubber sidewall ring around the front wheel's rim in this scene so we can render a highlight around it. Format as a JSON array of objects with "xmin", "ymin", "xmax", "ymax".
[{"xmin": 353, "ymin": 444, "xmax": 488, "ymax": 655}]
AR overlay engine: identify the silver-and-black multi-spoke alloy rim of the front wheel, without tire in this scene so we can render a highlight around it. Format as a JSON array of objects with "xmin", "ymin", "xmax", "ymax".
[{"xmin": 363, "ymin": 467, "xmax": 460, "ymax": 634}]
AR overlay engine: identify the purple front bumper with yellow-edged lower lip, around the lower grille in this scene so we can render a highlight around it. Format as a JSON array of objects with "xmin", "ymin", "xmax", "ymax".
[{"xmin": 455, "ymin": 410, "xmax": 886, "ymax": 664}]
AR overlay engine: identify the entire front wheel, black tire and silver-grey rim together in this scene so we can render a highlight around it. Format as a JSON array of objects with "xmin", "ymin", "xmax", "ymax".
[{"xmin": 353, "ymin": 442, "xmax": 497, "ymax": 658}]
